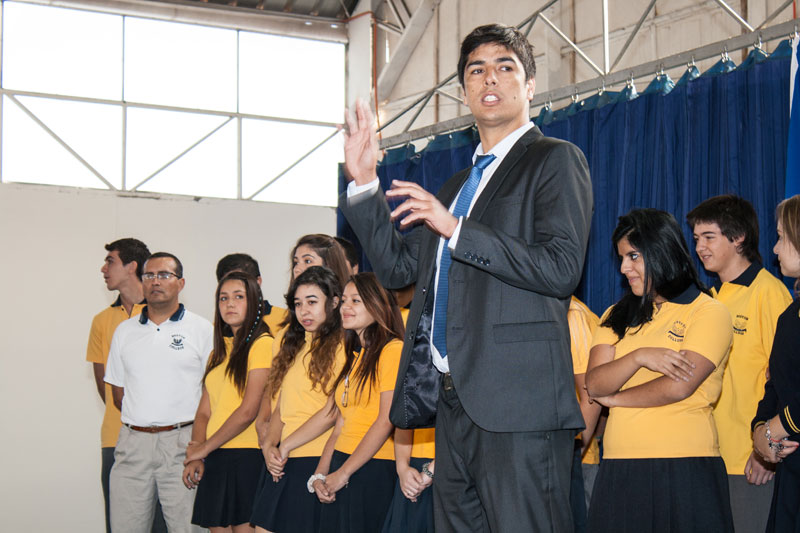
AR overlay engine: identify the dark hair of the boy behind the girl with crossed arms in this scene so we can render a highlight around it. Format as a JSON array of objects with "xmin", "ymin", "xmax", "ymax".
[{"xmin": 686, "ymin": 194, "xmax": 761, "ymax": 263}]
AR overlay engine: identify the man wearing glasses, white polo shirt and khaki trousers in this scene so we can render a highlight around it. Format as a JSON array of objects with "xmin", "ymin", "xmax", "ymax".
[{"xmin": 105, "ymin": 252, "xmax": 213, "ymax": 533}]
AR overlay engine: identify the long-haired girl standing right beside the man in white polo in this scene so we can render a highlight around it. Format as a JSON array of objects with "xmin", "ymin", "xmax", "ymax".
[{"xmin": 183, "ymin": 272, "xmax": 272, "ymax": 533}]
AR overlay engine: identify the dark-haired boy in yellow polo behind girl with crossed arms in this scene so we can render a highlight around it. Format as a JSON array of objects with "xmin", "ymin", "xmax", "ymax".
[{"xmin": 686, "ymin": 195, "xmax": 792, "ymax": 531}]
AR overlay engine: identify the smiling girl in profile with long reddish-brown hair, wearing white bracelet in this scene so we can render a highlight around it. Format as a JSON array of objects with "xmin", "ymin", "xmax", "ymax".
[{"xmin": 280, "ymin": 273, "xmax": 404, "ymax": 533}]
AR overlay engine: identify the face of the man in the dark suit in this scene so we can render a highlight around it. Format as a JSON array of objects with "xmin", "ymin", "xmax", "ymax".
[{"xmin": 464, "ymin": 43, "xmax": 536, "ymax": 129}]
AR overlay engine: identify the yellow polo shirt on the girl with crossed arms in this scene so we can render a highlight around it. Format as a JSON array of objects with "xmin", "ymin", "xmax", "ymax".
[{"xmin": 592, "ymin": 287, "xmax": 733, "ymax": 459}]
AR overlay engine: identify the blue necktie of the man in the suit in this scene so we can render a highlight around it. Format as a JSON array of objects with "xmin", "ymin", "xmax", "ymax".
[{"xmin": 433, "ymin": 154, "xmax": 495, "ymax": 358}]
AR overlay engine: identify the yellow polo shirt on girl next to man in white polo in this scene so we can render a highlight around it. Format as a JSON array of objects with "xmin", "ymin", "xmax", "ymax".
[{"xmin": 205, "ymin": 334, "xmax": 272, "ymax": 448}]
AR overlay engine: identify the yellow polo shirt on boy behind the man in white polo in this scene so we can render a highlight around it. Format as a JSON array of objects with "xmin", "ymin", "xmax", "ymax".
[{"xmin": 86, "ymin": 296, "xmax": 145, "ymax": 448}]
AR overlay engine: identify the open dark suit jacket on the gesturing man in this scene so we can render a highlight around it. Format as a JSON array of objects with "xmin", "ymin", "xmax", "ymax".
[{"xmin": 339, "ymin": 126, "xmax": 592, "ymax": 432}]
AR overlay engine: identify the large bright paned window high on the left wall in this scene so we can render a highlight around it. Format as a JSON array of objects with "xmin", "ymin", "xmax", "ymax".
[{"xmin": 0, "ymin": 1, "xmax": 345, "ymax": 206}]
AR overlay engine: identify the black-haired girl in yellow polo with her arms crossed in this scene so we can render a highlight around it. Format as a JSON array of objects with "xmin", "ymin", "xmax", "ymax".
[{"xmin": 586, "ymin": 209, "xmax": 733, "ymax": 533}]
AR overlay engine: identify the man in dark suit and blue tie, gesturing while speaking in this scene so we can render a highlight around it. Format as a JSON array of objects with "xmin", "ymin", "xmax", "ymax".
[{"xmin": 340, "ymin": 24, "xmax": 592, "ymax": 533}]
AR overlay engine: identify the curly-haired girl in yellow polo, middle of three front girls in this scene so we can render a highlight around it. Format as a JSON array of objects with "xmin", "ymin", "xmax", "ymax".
[{"xmin": 251, "ymin": 266, "xmax": 345, "ymax": 533}]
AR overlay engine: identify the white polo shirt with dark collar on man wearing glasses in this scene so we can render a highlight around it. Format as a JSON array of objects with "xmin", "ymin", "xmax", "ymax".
[{"xmin": 105, "ymin": 304, "xmax": 214, "ymax": 426}]
